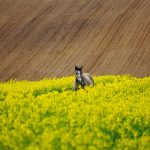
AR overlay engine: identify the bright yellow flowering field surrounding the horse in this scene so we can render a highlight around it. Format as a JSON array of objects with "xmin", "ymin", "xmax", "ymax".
[{"xmin": 0, "ymin": 75, "xmax": 150, "ymax": 150}]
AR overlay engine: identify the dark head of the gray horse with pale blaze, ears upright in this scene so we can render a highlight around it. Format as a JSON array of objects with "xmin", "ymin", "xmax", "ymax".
[{"xmin": 75, "ymin": 66, "xmax": 84, "ymax": 86}]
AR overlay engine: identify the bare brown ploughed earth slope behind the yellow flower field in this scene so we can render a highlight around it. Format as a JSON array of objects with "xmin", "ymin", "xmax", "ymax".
[{"xmin": 0, "ymin": 0, "xmax": 150, "ymax": 81}]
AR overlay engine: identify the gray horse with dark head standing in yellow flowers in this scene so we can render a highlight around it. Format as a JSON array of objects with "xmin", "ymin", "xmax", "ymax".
[{"xmin": 73, "ymin": 66, "xmax": 94, "ymax": 91}]
